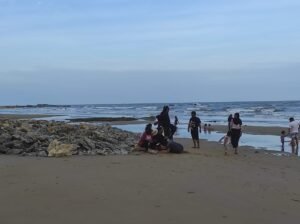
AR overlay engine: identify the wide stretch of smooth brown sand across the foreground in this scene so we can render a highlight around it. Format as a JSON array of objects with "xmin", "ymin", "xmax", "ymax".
[{"xmin": 0, "ymin": 139, "xmax": 300, "ymax": 224}]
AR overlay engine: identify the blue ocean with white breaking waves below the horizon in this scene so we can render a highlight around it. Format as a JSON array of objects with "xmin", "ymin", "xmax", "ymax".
[{"xmin": 0, "ymin": 101, "xmax": 300, "ymax": 127}]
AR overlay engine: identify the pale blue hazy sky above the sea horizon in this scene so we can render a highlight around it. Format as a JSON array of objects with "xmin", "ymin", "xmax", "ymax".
[{"xmin": 0, "ymin": 0, "xmax": 300, "ymax": 105}]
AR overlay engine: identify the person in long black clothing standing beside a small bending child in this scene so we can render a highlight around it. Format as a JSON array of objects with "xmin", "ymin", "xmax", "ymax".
[{"xmin": 230, "ymin": 113, "xmax": 243, "ymax": 154}]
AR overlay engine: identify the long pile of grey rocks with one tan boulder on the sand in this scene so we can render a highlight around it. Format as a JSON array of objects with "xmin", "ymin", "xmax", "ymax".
[{"xmin": 0, "ymin": 120, "xmax": 138, "ymax": 157}]
